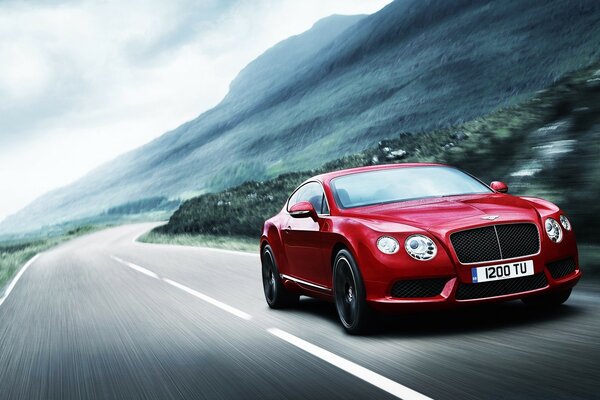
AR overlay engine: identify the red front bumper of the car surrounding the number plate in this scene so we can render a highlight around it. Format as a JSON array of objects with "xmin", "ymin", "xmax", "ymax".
[{"xmin": 357, "ymin": 216, "xmax": 581, "ymax": 311}]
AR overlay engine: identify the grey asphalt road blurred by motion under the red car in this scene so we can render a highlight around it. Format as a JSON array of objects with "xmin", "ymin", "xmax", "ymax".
[{"xmin": 0, "ymin": 224, "xmax": 600, "ymax": 400}]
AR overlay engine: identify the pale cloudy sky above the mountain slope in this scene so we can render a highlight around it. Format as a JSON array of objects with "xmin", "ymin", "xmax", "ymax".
[{"xmin": 0, "ymin": 0, "xmax": 390, "ymax": 220}]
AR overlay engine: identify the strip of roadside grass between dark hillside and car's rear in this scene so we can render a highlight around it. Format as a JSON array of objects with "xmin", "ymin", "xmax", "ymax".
[{"xmin": 138, "ymin": 231, "xmax": 258, "ymax": 253}]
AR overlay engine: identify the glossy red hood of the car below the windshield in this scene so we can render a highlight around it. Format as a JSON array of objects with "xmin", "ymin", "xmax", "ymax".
[{"xmin": 344, "ymin": 193, "xmax": 539, "ymax": 231}]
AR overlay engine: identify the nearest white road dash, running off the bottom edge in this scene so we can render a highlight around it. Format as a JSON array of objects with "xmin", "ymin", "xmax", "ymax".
[{"xmin": 267, "ymin": 328, "xmax": 431, "ymax": 400}]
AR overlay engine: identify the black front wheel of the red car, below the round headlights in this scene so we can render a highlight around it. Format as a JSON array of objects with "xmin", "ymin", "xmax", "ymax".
[{"xmin": 333, "ymin": 250, "xmax": 371, "ymax": 334}]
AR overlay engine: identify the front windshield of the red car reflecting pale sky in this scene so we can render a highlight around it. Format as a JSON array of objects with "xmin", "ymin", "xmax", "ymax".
[{"xmin": 331, "ymin": 166, "xmax": 492, "ymax": 208}]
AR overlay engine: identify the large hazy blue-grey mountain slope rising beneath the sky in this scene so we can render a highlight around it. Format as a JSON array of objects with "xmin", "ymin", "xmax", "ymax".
[{"xmin": 0, "ymin": 0, "xmax": 600, "ymax": 232}]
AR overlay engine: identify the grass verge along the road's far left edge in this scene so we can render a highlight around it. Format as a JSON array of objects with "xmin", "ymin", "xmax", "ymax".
[{"xmin": 0, "ymin": 225, "xmax": 106, "ymax": 296}]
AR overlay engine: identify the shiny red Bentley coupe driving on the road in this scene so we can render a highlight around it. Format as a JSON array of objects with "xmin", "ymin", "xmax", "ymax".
[{"xmin": 261, "ymin": 164, "xmax": 581, "ymax": 333}]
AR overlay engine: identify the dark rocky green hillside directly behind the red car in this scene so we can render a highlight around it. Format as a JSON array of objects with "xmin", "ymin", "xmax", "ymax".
[{"xmin": 156, "ymin": 63, "xmax": 600, "ymax": 244}]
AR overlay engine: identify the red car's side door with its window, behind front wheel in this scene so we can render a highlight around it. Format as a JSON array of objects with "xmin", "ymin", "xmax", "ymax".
[{"xmin": 282, "ymin": 182, "xmax": 330, "ymax": 286}]
